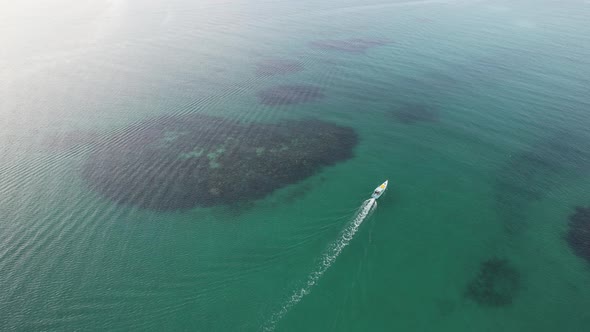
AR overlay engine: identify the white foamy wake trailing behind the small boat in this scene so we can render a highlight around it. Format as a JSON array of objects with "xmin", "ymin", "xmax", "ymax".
[{"xmin": 262, "ymin": 198, "xmax": 377, "ymax": 331}]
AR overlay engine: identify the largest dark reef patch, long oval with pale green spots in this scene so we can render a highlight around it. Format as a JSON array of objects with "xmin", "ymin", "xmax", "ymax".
[{"xmin": 82, "ymin": 115, "xmax": 357, "ymax": 211}]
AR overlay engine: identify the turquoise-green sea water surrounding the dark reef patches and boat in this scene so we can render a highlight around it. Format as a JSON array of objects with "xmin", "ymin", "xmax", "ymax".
[{"xmin": 0, "ymin": 0, "xmax": 590, "ymax": 331}]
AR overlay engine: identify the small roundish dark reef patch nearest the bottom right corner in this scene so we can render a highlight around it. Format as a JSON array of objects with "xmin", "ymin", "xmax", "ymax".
[{"xmin": 465, "ymin": 258, "xmax": 521, "ymax": 307}]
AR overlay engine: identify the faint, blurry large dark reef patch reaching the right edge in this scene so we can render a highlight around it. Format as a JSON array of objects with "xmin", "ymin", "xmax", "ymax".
[{"xmin": 495, "ymin": 131, "xmax": 590, "ymax": 233}]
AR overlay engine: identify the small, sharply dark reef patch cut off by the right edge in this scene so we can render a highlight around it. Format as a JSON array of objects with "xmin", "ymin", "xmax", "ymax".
[{"xmin": 565, "ymin": 206, "xmax": 590, "ymax": 263}]
